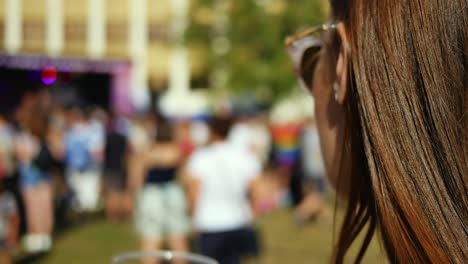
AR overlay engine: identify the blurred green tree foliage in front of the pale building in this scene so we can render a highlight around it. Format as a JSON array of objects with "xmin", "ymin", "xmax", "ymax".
[{"xmin": 188, "ymin": 0, "xmax": 327, "ymax": 99}]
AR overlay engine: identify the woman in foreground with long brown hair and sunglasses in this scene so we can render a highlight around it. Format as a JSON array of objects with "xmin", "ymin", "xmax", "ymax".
[{"xmin": 287, "ymin": 0, "xmax": 468, "ymax": 263}]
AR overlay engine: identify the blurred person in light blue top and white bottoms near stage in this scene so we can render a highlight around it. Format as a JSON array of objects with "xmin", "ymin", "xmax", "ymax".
[{"xmin": 65, "ymin": 107, "xmax": 103, "ymax": 212}]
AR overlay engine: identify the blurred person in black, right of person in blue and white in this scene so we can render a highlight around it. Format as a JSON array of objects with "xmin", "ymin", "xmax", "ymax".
[{"xmin": 103, "ymin": 115, "xmax": 129, "ymax": 220}]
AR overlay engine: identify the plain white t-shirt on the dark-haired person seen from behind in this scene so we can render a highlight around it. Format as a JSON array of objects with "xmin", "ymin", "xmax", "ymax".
[{"xmin": 187, "ymin": 143, "xmax": 261, "ymax": 232}]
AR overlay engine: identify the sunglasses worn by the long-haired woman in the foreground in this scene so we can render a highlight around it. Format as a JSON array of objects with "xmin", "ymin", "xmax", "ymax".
[{"xmin": 285, "ymin": 23, "xmax": 336, "ymax": 91}]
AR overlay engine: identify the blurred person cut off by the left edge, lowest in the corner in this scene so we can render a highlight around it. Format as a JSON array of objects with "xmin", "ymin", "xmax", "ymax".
[{"xmin": 0, "ymin": 182, "xmax": 20, "ymax": 264}]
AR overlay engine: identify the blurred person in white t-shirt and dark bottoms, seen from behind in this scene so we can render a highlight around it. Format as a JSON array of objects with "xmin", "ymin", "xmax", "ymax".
[{"xmin": 186, "ymin": 117, "xmax": 261, "ymax": 264}]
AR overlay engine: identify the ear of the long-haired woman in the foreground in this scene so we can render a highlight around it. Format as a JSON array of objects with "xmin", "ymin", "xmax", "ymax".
[{"xmin": 334, "ymin": 23, "xmax": 351, "ymax": 105}]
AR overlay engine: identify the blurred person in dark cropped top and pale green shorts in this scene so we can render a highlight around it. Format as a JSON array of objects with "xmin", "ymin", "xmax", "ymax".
[{"xmin": 133, "ymin": 121, "xmax": 189, "ymax": 263}]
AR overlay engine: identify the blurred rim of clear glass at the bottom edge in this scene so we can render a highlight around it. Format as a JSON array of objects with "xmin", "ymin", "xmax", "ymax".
[{"xmin": 112, "ymin": 251, "xmax": 219, "ymax": 264}]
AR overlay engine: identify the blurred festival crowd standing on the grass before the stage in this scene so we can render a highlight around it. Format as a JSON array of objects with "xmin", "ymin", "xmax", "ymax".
[{"xmin": 0, "ymin": 91, "xmax": 327, "ymax": 264}]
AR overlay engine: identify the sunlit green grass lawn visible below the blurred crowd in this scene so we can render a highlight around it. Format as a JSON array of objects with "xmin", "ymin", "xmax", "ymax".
[{"xmin": 39, "ymin": 210, "xmax": 385, "ymax": 264}]
